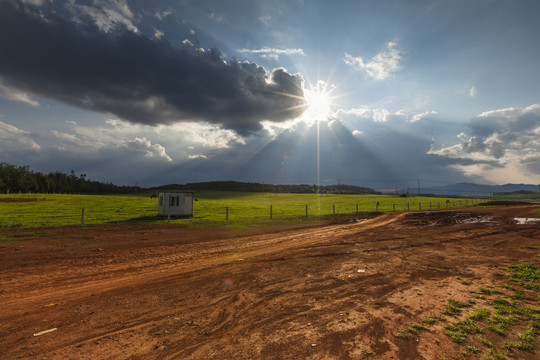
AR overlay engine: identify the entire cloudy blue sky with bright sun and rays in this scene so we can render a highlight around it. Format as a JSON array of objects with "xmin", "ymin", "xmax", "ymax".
[{"xmin": 0, "ymin": 0, "xmax": 540, "ymax": 190}]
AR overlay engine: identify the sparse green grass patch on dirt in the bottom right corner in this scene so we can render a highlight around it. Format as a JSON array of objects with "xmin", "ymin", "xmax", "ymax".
[{"xmin": 396, "ymin": 263, "xmax": 540, "ymax": 359}]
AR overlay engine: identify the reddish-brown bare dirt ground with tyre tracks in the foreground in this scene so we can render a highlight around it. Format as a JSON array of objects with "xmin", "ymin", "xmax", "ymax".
[{"xmin": 0, "ymin": 206, "xmax": 540, "ymax": 359}]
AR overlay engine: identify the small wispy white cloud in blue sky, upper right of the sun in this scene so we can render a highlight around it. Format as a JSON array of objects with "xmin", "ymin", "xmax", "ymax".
[{"xmin": 343, "ymin": 41, "xmax": 402, "ymax": 80}]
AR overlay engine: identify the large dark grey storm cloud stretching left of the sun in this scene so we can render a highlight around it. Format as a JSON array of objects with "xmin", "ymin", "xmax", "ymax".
[{"xmin": 0, "ymin": 1, "xmax": 305, "ymax": 134}]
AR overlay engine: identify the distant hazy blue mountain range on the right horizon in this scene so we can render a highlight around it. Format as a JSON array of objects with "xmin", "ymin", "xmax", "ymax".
[{"xmin": 422, "ymin": 183, "xmax": 540, "ymax": 195}]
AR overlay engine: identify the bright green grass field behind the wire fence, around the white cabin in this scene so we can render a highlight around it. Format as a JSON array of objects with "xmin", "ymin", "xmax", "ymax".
[{"xmin": 0, "ymin": 192, "xmax": 490, "ymax": 228}]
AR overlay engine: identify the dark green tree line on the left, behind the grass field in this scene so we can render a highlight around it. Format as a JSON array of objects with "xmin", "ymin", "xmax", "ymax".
[{"xmin": 0, "ymin": 162, "xmax": 141, "ymax": 194}]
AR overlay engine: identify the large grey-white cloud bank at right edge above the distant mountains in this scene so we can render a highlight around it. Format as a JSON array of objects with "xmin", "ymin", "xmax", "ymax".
[{"xmin": 430, "ymin": 104, "xmax": 540, "ymax": 180}]
